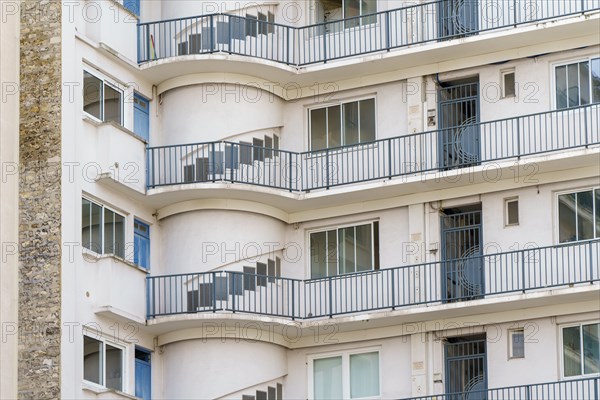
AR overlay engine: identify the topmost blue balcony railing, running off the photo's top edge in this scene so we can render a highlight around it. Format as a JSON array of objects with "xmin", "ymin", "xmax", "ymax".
[{"xmin": 138, "ymin": 0, "xmax": 600, "ymax": 67}]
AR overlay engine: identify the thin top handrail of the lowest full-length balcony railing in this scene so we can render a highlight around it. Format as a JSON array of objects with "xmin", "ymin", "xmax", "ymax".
[{"xmin": 146, "ymin": 238, "xmax": 600, "ymax": 283}]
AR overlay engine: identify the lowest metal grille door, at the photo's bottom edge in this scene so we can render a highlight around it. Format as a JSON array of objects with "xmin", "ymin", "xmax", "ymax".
[{"xmin": 445, "ymin": 335, "xmax": 487, "ymax": 400}]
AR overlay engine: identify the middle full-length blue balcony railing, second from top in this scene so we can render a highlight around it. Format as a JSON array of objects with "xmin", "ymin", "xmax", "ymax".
[{"xmin": 147, "ymin": 104, "xmax": 600, "ymax": 192}]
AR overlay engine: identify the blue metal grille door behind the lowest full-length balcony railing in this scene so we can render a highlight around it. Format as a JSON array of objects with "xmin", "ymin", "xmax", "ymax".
[{"xmin": 441, "ymin": 209, "xmax": 484, "ymax": 301}]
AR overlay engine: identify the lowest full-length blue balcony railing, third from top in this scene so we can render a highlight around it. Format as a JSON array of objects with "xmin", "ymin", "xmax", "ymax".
[{"xmin": 146, "ymin": 239, "xmax": 600, "ymax": 320}]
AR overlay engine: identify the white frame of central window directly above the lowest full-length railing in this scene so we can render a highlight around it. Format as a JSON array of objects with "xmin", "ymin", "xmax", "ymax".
[{"xmin": 306, "ymin": 219, "xmax": 381, "ymax": 279}]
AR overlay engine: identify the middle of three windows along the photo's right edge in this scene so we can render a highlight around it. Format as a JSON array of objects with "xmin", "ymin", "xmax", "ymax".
[{"xmin": 558, "ymin": 188, "xmax": 600, "ymax": 243}]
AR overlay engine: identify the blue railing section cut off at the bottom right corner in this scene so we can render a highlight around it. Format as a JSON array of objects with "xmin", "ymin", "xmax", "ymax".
[{"xmin": 402, "ymin": 377, "xmax": 600, "ymax": 400}]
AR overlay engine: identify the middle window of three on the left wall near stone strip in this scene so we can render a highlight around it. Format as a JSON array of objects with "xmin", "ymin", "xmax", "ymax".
[{"xmin": 81, "ymin": 198, "xmax": 125, "ymax": 258}]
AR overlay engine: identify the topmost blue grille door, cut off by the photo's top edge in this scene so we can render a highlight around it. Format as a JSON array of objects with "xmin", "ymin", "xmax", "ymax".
[{"xmin": 438, "ymin": 0, "xmax": 479, "ymax": 40}]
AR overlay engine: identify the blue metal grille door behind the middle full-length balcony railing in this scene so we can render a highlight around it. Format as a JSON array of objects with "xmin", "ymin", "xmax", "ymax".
[{"xmin": 438, "ymin": 81, "xmax": 480, "ymax": 169}]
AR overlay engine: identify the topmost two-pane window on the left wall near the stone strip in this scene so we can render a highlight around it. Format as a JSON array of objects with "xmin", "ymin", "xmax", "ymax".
[{"xmin": 83, "ymin": 71, "xmax": 123, "ymax": 125}]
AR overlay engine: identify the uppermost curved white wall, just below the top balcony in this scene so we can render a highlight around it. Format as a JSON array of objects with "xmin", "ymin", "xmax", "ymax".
[{"xmin": 152, "ymin": 83, "xmax": 283, "ymax": 145}]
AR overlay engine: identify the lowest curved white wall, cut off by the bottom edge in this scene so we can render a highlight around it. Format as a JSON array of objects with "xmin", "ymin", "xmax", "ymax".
[{"xmin": 163, "ymin": 337, "xmax": 287, "ymax": 399}]
